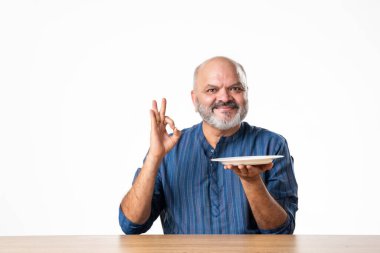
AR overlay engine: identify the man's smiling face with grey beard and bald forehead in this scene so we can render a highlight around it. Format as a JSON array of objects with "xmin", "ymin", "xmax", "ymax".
[{"xmin": 192, "ymin": 59, "xmax": 248, "ymax": 130}]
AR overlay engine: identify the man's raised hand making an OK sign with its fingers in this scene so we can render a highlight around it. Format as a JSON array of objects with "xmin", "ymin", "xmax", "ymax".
[{"xmin": 148, "ymin": 98, "xmax": 181, "ymax": 160}]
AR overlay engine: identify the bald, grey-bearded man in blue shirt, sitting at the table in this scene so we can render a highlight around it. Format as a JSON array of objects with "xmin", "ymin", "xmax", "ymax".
[{"xmin": 119, "ymin": 57, "xmax": 298, "ymax": 234}]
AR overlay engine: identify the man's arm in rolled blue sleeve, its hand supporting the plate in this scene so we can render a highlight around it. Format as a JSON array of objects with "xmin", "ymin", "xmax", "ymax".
[{"xmin": 225, "ymin": 140, "xmax": 297, "ymax": 234}]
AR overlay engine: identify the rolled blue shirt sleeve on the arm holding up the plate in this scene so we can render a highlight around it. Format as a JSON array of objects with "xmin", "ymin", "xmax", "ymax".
[{"xmin": 260, "ymin": 138, "xmax": 298, "ymax": 234}]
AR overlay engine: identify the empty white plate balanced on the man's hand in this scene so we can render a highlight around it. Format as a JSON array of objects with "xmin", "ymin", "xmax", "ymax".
[{"xmin": 211, "ymin": 155, "xmax": 284, "ymax": 165}]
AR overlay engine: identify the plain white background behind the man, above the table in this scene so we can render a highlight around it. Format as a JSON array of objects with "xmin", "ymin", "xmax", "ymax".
[{"xmin": 0, "ymin": 0, "xmax": 380, "ymax": 235}]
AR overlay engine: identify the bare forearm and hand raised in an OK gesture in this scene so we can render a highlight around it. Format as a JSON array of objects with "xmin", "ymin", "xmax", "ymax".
[{"xmin": 120, "ymin": 99, "xmax": 181, "ymax": 227}]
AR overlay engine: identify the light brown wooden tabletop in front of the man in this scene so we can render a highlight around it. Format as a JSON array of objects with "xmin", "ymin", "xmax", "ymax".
[{"xmin": 0, "ymin": 235, "xmax": 380, "ymax": 253}]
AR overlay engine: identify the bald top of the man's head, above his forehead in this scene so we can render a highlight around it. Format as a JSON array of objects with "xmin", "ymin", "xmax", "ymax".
[{"xmin": 193, "ymin": 56, "xmax": 247, "ymax": 90}]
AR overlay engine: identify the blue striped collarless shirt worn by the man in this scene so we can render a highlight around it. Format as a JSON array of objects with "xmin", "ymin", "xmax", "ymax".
[{"xmin": 119, "ymin": 122, "xmax": 298, "ymax": 234}]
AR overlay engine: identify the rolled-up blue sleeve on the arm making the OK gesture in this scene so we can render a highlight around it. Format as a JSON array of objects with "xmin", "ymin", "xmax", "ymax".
[{"xmin": 119, "ymin": 168, "xmax": 165, "ymax": 234}]
